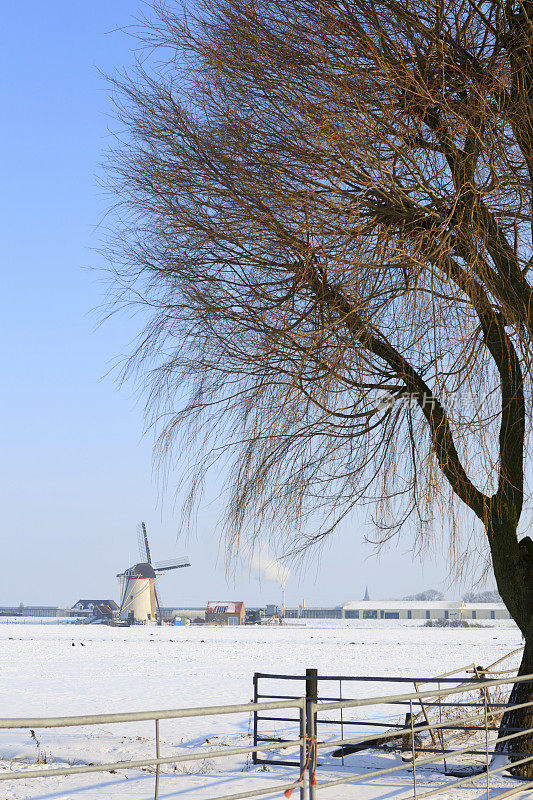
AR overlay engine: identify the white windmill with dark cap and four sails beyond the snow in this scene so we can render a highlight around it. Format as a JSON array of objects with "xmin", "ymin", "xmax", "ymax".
[{"xmin": 117, "ymin": 522, "xmax": 191, "ymax": 623}]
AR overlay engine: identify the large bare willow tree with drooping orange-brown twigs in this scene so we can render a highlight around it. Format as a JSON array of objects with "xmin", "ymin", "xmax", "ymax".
[{"xmin": 107, "ymin": 0, "xmax": 533, "ymax": 772}]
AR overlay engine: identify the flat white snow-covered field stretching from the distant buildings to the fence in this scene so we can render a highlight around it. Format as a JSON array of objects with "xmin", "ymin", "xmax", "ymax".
[{"xmin": 0, "ymin": 620, "xmax": 528, "ymax": 800}]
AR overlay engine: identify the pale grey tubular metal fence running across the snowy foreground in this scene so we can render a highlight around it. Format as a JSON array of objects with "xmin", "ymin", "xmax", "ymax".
[{"xmin": 0, "ymin": 675, "xmax": 533, "ymax": 800}]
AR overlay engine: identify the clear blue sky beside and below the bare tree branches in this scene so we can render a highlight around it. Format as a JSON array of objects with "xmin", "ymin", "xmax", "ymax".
[{"xmin": 0, "ymin": 0, "xmax": 470, "ymax": 605}]
